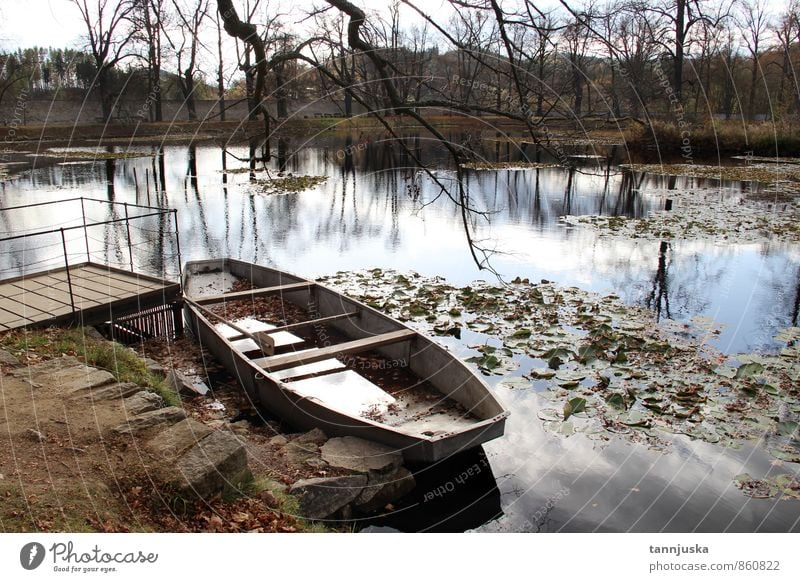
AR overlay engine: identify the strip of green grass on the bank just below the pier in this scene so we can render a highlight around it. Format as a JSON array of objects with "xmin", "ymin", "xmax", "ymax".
[{"xmin": 0, "ymin": 328, "xmax": 180, "ymax": 406}]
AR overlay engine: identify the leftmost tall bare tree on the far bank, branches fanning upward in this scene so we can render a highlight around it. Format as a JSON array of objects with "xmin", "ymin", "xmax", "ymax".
[{"xmin": 71, "ymin": 0, "xmax": 136, "ymax": 121}]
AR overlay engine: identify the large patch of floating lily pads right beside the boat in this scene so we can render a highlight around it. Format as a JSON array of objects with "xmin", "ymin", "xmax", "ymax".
[{"xmin": 320, "ymin": 269, "xmax": 800, "ymax": 493}]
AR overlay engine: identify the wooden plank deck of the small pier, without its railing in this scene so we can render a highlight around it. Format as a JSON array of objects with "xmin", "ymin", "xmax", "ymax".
[{"xmin": 0, "ymin": 263, "xmax": 181, "ymax": 331}]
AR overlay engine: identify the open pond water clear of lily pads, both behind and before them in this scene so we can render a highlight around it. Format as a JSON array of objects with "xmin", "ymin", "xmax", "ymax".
[{"xmin": 0, "ymin": 135, "xmax": 800, "ymax": 531}]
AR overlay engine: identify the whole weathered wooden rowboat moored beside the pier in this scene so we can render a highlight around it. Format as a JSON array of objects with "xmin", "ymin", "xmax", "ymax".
[{"xmin": 183, "ymin": 259, "xmax": 508, "ymax": 462}]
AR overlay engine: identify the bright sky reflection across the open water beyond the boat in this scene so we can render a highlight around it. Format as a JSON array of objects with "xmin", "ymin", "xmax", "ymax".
[{"xmin": 0, "ymin": 144, "xmax": 800, "ymax": 351}]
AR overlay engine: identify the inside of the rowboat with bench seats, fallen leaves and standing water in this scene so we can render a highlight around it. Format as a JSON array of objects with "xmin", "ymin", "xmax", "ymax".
[{"xmin": 184, "ymin": 264, "xmax": 503, "ymax": 437}]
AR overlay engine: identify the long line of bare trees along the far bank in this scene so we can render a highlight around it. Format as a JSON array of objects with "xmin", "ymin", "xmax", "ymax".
[{"xmin": 0, "ymin": 0, "xmax": 800, "ymax": 125}]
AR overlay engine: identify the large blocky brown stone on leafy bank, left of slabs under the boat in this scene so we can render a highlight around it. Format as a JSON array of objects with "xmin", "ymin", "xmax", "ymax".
[{"xmin": 177, "ymin": 431, "xmax": 250, "ymax": 499}]
